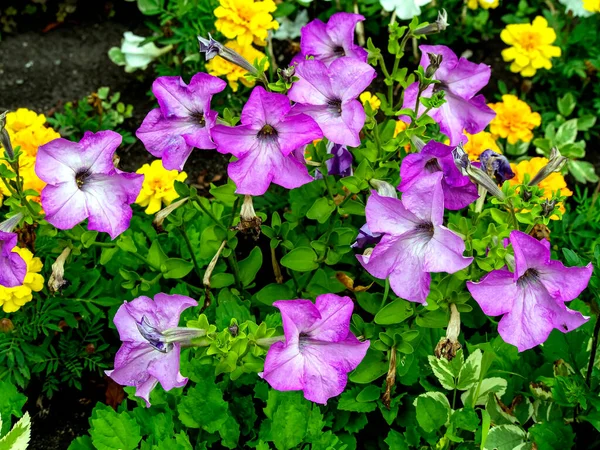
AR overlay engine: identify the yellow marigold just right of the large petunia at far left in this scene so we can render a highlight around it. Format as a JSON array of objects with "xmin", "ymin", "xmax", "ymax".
[{"xmin": 135, "ymin": 159, "xmax": 187, "ymax": 214}]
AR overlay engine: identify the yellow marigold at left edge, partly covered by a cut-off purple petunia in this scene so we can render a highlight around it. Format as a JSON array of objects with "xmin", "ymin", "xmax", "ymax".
[{"xmin": 0, "ymin": 247, "xmax": 44, "ymax": 313}]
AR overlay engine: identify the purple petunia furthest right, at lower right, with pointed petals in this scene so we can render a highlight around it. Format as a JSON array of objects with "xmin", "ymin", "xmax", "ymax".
[{"xmin": 467, "ymin": 230, "xmax": 593, "ymax": 352}]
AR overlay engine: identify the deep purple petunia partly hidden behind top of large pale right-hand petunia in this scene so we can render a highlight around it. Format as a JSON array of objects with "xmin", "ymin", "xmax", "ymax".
[{"xmin": 398, "ymin": 141, "xmax": 479, "ymax": 210}]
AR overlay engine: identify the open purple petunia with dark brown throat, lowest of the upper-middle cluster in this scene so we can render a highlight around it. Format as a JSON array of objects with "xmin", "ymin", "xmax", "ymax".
[{"xmin": 212, "ymin": 86, "xmax": 323, "ymax": 195}]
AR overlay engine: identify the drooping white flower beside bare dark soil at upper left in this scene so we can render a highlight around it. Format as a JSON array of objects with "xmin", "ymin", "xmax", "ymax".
[{"xmin": 108, "ymin": 31, "xmax": 173, "ymax": 73}]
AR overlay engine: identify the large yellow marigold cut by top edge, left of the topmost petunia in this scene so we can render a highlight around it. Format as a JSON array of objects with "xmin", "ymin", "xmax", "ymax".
[{"xmin": 215, "ymin": 0, "xmax": 279, "ymax": 47}]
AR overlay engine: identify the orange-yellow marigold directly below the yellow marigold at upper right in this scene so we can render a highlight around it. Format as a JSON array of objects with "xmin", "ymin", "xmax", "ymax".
[{"xmin": 488, "ymin": 94, "xmax": 542, "ymax": 144}]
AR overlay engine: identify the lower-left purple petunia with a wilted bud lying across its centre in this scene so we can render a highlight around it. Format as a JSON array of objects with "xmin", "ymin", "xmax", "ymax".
[{"xmin": 106, "ymin": 293, "xmax": 198, "ymax": 407}]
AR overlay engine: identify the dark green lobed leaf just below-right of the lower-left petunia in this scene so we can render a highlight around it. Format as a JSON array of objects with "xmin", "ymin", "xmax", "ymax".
[{"xmin": 177, "ymin": 365, "xmax": 229, "ymax": 433}]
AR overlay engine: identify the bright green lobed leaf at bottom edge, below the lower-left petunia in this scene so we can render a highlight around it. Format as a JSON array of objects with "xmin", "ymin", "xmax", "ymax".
[{"xmin": 90, "ymin": 408, "xmax": 142, "ymax": 450}]
